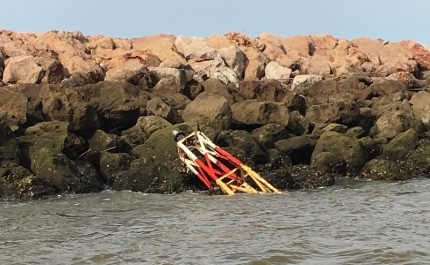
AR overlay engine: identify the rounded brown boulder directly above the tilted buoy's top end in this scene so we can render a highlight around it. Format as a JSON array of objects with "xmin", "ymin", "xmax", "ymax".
[{"xmin": 182, "ymin": 93, "xmax": 232, "ymax": 139}]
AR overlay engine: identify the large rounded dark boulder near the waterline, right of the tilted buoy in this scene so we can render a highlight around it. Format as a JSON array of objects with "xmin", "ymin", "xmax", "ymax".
[{"xmin": 311, "ymin": 131, "xmax": 366, "ymax": 175}]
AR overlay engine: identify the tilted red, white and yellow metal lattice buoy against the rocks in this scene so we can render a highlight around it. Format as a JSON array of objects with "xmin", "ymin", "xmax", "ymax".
[{"xmin": 172, "ymin": 131, "xmax": 281, "ymax": 195}]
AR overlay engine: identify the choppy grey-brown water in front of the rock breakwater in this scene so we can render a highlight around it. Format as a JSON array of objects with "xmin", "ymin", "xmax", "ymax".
[{"xmin": 0, "ymin": 176, "xmax": 430, "ymax": 265}]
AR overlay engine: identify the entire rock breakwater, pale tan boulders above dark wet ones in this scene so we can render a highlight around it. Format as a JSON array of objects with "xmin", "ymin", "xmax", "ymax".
[{"xmin": 0, "ymin": 30, "xmax": 430, "ymax": 198}]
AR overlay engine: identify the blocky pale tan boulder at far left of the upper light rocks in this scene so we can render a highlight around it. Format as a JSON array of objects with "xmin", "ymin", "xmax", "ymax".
[{"xmin": 3, "ymin": 56, "xmax": 45, "ymax": 84}]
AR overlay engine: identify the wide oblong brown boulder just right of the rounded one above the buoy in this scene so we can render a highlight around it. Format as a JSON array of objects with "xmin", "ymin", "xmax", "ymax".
[{"xmin": 232, "ymin": 100, "xmax": 290, "ymax": 126}]
